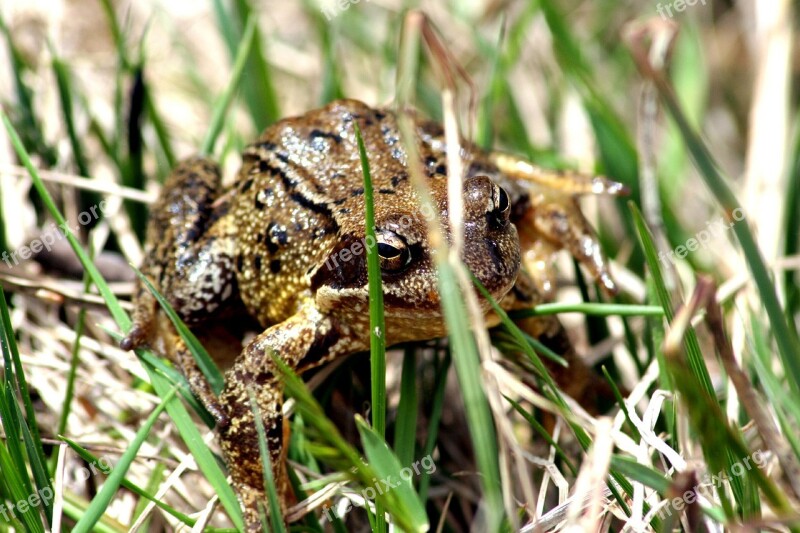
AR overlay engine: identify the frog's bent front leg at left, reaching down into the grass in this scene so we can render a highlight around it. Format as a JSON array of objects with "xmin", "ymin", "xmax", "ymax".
[{"xmin": 218, "ymin": 297, "xmax": 367, "ymax": 531}]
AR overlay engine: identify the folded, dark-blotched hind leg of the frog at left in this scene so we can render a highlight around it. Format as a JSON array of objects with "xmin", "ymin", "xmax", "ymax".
[{"xmin": 120, "ymin": 158, "xmax": 236, "ymax": 418}]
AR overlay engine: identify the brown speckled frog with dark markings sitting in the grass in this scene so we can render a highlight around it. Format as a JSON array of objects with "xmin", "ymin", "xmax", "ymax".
[{"xmin": 121, "ymin": 99, "xmax": 624, "ymax": 531}]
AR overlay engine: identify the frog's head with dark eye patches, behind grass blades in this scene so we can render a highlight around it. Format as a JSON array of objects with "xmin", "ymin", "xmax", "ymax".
[{"xmin": 311, "ymin": 175, "xmax": 520, "ymax": 338}]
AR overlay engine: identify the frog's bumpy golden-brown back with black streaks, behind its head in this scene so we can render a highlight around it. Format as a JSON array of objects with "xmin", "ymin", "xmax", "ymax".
[{"xmin": 230, "ymin": 100, "xmax": 414, "ymax": 324}]
